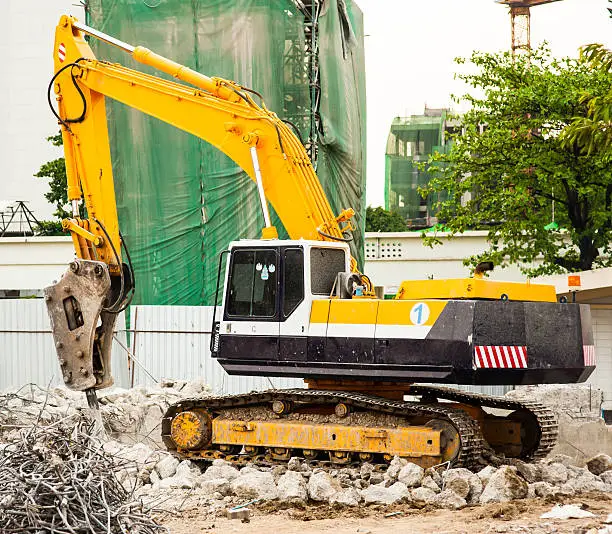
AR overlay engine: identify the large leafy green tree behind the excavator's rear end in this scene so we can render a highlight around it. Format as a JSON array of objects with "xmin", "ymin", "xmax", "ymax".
[{"xmin": 421, "ymin": 47, "xmax": 612, "ymax": 276}]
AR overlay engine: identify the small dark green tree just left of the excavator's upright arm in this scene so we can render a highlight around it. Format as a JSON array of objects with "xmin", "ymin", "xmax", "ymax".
[{"xmin": 34, "ymin": 134, "xmax": 70, "ymax": 235}]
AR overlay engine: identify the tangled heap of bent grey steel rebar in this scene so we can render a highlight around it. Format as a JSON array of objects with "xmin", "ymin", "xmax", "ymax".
[{"xmin": 0, "ymin": 415, "xmax": 166, "ymax": 534}]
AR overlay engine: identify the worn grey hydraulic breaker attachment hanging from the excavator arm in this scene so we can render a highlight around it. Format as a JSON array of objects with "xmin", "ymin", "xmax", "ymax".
[{"xmin": 44, "ymin": 259, "xmax": 117, "ymax": 398}]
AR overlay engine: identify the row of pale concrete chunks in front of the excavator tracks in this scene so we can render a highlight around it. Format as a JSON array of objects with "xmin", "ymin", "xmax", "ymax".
[{"xmin": 105, "ymin": 442, "xmax": 612, "ymax": 512}]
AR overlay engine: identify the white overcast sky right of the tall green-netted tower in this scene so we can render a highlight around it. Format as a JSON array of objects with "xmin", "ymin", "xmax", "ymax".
[{"xmin": 356, "ymin": 0, "xmax": 612, "ymax": 206}]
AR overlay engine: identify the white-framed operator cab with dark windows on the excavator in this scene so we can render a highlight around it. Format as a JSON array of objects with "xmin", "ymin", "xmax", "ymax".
[{"xmin": 211, "ymin": 240, "xmax": 351, "ymax": 361}]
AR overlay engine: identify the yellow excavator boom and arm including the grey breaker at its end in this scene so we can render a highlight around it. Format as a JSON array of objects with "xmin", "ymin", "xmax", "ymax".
[{"xmin": 45, "ymin": 16, "xmax": 357, "ymax": 393}]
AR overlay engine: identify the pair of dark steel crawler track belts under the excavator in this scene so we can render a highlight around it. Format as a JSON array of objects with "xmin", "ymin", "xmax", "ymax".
[{"xmin": 162, "ymin": 386, "xmax": 557, "ymax": 467}]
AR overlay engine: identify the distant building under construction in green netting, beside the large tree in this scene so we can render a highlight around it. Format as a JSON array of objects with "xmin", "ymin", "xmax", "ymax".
[{"xmin": 385, "ymin": 107, "xmax": 456, "ymax": 228}]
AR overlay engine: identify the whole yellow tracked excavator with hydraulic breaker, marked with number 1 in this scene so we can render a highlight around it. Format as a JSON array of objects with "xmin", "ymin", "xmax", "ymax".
[{"xmin": 45, "ymin": 16, "xmax": 594, "ymax": 466}]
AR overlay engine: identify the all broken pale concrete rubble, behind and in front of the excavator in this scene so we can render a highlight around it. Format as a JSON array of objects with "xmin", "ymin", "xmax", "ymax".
[{"xmin": 0, "ymin": 383, "xmax": 612, "ymax": 514}]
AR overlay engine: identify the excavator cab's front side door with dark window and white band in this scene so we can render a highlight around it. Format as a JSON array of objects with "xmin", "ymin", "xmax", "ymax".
[{"xmin": 219, "ymin": 247, "xmax": 280, "ymax": 360}]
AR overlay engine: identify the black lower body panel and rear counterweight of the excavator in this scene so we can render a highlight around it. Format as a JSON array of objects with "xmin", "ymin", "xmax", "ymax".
[{"xmin": 217, "ymin": 301, "xmax": 594, "ymax": 385}]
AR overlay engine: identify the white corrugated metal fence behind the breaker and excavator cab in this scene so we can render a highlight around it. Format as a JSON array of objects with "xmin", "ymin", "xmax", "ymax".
[{"xmin": 0, "ymin": 299, "xmax": 511, "ymax": 395}]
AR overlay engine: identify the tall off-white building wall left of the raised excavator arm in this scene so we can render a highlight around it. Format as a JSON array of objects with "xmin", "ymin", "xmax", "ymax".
[{"xmin": 0, "ymin": 0, "xmax": 84, "ymax": 220}]
